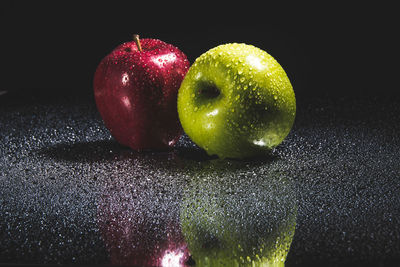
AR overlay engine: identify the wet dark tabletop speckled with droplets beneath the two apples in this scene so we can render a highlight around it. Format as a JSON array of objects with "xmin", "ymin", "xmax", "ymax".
[{"xmin": 0, "ymin": 91, "xmax": 400, "ymax": 266}]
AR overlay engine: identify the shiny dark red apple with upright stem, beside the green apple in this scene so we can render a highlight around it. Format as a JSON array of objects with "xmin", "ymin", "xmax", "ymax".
[{"xmin": 93, "ymin": 39, "xmax": 190, "ymax": 151}]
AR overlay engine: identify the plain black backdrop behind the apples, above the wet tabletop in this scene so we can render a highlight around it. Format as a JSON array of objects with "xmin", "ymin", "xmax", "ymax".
[{"xmin": 0, "ymin": 1, "xmax": 398, "ymax": 100}]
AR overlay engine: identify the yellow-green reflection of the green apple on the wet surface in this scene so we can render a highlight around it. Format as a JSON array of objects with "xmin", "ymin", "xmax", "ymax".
[{"xmin": 180, "ymin": 160, "xmax": 297, "ymax": 267}]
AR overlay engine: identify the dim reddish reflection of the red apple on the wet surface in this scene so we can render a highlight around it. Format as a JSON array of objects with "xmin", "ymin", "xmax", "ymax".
[{"xmin": 98, "ymin": 155, "xmax": 189, "ymax": 267}]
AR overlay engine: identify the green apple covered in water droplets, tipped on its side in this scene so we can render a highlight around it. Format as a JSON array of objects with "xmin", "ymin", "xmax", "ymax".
[{"xmin": 178, "ymin": 43, "xmax": 296, "ymax": 158}]
